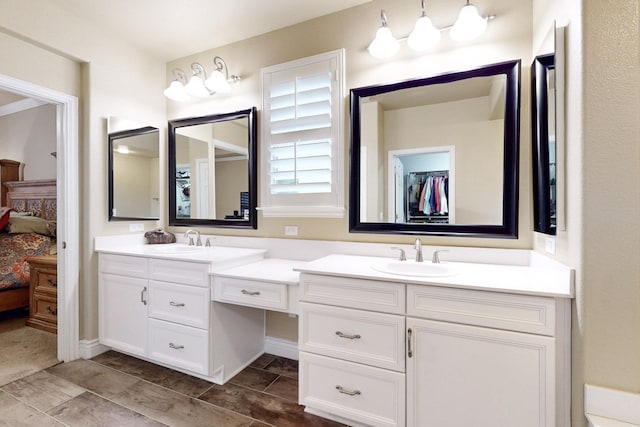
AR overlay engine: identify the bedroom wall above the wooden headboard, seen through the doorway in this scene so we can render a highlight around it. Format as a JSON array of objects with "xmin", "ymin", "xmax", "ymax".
[{"xmin": 0, "ymin": 105, "xmax": 56, "ymax": 179}]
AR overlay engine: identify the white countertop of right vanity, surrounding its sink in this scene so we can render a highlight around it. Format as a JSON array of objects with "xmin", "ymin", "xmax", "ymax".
[{"xmin": 295, "ymin": 255, "xmax": 574, "ymax": 298}]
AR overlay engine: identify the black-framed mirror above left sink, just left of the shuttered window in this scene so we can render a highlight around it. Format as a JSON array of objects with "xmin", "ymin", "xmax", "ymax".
[{"xmin": 169, "ymin": 107, "xmax": 258, "ymax": 229}]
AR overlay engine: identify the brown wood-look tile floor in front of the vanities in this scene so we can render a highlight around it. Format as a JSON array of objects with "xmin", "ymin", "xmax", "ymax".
[{"xmin": 0, "ymin": 351, "xmax": 342, "ymax": 427}]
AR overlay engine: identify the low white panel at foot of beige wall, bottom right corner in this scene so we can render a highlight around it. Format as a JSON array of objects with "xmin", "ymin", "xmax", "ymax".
[{"xmin": 584, "ymin": 384, "xmax": 640, "ymax": 426}]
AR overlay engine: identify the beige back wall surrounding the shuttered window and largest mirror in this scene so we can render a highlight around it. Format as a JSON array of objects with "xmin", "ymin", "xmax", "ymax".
[{"xmin": 165, "ymin": 0, "xmax": 532, "ymax": 248}]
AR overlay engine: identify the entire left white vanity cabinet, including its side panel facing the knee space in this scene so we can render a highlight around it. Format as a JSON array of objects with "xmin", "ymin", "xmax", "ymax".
[{"xmin": 98, "ymin": 251, "xmax": 264, "ymax": 384}]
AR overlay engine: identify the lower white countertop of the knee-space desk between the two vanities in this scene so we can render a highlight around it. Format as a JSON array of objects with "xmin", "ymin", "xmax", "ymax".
[{"xmin": 212, "ymin": 258, "xmax": 306, "ymax": 285}]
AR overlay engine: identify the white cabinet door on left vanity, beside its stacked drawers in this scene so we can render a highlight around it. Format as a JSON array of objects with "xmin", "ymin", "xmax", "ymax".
[{"xmin": 98, "ymin": 273, "xmax": 148, "ymax": 356}]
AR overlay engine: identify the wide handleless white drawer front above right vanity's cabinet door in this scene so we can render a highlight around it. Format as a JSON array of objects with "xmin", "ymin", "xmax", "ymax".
[{"xmin": 407, "ymin": 285, "xmax": 556, "ymax": 336}]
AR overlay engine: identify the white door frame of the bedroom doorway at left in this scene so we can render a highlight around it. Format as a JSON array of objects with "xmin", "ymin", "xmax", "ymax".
[{"xmin": 0, "ymin": 74, "xmax": 80, "ymax": 362}]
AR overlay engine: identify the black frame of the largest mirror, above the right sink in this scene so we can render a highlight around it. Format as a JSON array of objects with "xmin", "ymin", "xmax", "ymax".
[{"xmin": 349, "ymin": 59, "xmax": 521, "ymax": 239}]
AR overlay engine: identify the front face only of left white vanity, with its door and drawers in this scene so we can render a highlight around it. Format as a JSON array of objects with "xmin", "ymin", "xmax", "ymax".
[{"xmin": 98, "ymin": 254, "xmax": 211, "ymax": 375}]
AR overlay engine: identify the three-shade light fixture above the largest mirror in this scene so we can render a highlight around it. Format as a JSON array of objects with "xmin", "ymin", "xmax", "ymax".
[{"xmin": 368, "ymin": 0, "xmax": 495, "ymax": 59}]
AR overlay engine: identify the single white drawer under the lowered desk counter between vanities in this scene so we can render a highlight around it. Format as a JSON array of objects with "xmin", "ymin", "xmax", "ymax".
[{"xmin": 213, "ymin": 276, "xmax": 288, "ymax": 310}]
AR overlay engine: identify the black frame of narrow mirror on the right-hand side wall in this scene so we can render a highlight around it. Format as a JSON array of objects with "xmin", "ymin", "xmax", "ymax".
[{"xmin": 531, "ymin": 53, "xmax": 557, "ymax": 235}]
